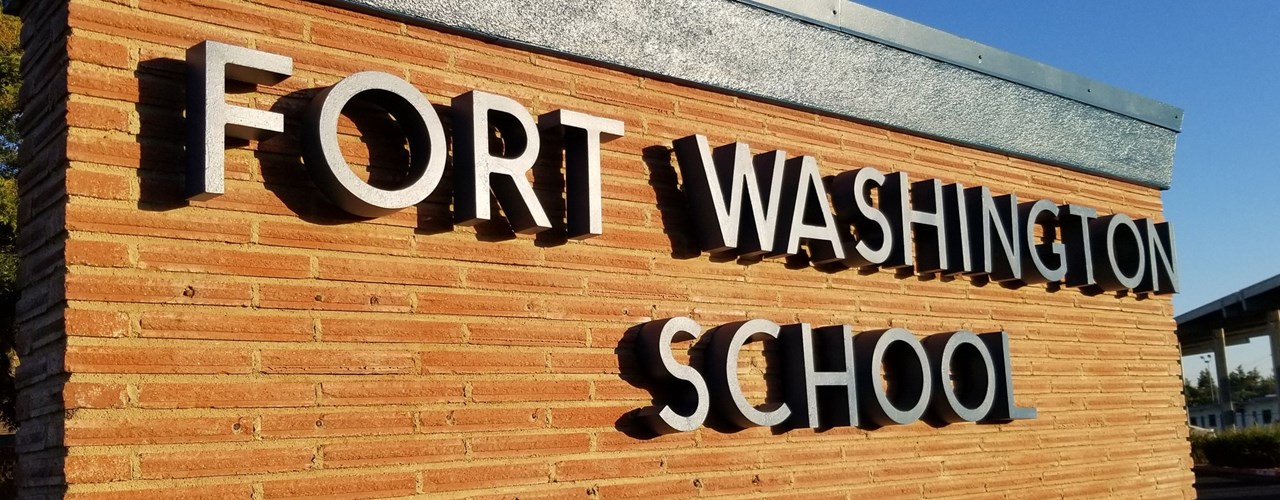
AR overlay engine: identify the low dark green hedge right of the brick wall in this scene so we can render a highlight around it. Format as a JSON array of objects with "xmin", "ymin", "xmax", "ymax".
[{"xmin": 1190, "ymin": 426, "xmax": 1280, "ymax": 469}]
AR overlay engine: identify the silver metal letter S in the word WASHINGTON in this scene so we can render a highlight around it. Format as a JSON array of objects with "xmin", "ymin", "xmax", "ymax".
[{"xmin": 832, "ymin": 166, "xmax": 893, "ymax": 269}]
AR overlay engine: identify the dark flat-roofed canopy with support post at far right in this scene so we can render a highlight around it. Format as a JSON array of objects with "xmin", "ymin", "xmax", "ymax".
[{"xmin": 1175, "ymin": 275, "xmax": 1280, "ymax": 429}]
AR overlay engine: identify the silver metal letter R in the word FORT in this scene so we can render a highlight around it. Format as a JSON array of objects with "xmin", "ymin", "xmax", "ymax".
[{"xmin": 453, "ymin": 91, "xmax": 552, "ymax": 234}]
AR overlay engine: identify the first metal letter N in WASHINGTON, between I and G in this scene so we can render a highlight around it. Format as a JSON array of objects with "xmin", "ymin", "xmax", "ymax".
[{"xmin": 965, "ymin": 187, "xmax": 1023, "ymax": 283}]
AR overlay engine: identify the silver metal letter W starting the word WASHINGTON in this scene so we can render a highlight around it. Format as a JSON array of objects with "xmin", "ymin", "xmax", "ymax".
[{"xmin": 675, "ymin": 136, "xmax": 786, "ymax": 256}]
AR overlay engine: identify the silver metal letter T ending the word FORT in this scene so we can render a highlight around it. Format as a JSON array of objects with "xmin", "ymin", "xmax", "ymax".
[{"xmin": 538, "ymin": 110, "xmax": 623, "ymax": 239}]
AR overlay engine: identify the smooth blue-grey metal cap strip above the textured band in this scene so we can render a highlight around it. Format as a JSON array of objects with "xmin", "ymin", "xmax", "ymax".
[{"xmin": 737, "ymin": 0, "xmax": 1183, "ymax": 132}]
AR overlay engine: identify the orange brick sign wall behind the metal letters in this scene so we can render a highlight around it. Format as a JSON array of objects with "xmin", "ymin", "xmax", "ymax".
[{"xmin": 10, "ymin": 0, "xmax": 1192, "ymax": 499}]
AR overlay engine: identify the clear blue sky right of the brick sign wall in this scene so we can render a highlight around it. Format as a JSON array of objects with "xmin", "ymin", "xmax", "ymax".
[{"xmin": 858, "ymin": 0, "xmax": 1280, "ymax": 381}]
